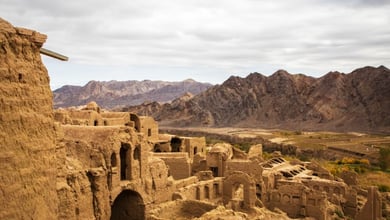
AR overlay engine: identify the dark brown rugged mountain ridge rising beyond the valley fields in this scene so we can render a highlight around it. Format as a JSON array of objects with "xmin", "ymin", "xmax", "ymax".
[{"xmin": 125, "ymin": 66, "xmax": 390, "ymax": 131}]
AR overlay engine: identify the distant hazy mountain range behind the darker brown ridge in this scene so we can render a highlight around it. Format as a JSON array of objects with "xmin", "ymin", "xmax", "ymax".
[{"xmin": 53, "ymin": 79, "xmax": 212, "ymax": 109}]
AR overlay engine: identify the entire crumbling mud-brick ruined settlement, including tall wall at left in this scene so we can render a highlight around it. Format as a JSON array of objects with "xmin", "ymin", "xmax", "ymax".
[{"xmin": 0, "ymin": 19, "xmax": 381, "ymax": 219}]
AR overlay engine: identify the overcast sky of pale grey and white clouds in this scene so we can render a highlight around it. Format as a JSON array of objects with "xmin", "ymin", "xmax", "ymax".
[{"xmin": 0, "ymin": 0, "xmax": 390, "ymax": 89}]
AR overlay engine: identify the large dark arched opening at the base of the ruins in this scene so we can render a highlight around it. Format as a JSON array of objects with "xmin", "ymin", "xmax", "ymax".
[{"xmin": 110, "ymin": 190, "xmax": 145, "ymax": 220}]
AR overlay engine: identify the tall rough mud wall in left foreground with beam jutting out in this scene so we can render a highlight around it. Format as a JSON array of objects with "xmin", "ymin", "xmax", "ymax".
[{"xmin": 0, "ymin": 18, "xmax": 58, "ymax": 219}]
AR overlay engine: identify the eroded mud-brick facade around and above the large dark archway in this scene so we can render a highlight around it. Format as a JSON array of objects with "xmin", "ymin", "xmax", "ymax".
[{"xmin": 57, "ymin": 125, "xmax": 175, "ymax": 219}]
